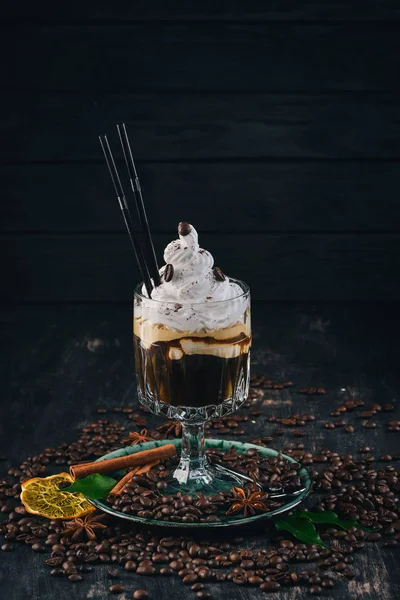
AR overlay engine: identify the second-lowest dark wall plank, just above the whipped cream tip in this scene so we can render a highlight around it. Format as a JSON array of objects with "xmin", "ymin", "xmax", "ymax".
[{"xmin": 0, "ymin": 161, "xmax": 400, "ymax": 232}]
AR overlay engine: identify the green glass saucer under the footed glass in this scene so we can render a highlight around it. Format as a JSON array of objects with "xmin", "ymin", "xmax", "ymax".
[{"xmin": 89, "ymin": 439, "xmax": 311, "ymax": 529}]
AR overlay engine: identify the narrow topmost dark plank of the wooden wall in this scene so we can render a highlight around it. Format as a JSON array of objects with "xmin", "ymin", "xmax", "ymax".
[{"xmin": 0, "ymin": 0, "xmax": 400, "ymax": 24}]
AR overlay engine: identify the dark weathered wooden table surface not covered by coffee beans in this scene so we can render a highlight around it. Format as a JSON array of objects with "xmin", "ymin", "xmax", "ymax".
[{"xmin": 0, "ymin": 304, "xmax": 400, "ymax": 600}]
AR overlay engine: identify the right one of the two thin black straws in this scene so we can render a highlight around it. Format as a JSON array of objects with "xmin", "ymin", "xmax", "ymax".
[{"xmin": 117, "ymin": 123, "xmax": 161, "ymax": 286}]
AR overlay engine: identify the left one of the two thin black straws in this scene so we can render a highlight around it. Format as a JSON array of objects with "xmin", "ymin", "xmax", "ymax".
[{"xmin": 99, "ymin": 134, "xmax": 153, "ymax": 298}]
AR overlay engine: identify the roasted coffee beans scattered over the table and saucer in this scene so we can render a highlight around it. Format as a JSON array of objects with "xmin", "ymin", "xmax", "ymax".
[{"xmin": 0, "ymin": 375, "xmax": 400, "ymax": 600}]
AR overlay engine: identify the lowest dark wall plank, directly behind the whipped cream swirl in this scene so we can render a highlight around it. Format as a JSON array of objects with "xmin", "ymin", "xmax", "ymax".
[{"xmin": 0, "ymin": 233, "xmax": 400, "ymax": 302}]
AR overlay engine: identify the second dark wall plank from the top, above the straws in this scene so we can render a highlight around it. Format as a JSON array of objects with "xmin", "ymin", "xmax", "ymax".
[{"xmin": 2, "ymin": 22, "xmax": 400, "ymax": 92}]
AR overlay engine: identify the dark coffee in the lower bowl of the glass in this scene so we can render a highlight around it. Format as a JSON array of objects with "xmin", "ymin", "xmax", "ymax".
[{"xmin": 133, "ymin": 334, "xmax": 250, "ymax": 408}]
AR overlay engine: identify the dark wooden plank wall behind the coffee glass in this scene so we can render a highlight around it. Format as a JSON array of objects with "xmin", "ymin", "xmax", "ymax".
[{"xmin": 0, "ymin": 0, "xmax": 400, "ymax": 303}]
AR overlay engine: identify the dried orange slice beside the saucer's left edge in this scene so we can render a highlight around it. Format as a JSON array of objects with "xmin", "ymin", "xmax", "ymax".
[{"xmin": 20, "ymin": 473, "xmax": 96, "ymax": 519}]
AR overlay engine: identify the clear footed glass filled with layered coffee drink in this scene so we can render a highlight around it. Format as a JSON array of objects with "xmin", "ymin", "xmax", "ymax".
[{"xmin": 133, "ymin": 279, "xmax": 251, "ymax": 494}]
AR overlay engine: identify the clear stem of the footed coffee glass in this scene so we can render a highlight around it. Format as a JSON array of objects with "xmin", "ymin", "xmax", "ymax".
[{"xmin": 174, "ymin": 423, "xmax": 213, "ymax": 486}]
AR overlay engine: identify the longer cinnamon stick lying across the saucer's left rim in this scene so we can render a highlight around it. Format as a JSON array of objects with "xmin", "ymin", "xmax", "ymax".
[{"xmin": 69, "ymin": 444, "xmax": 176, "ymax": 479}]
